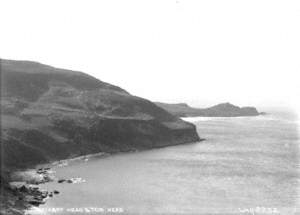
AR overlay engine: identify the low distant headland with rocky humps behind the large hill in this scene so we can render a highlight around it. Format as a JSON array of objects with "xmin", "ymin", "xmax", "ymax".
[{"xmin": 156, "ymin": 102, "xmax": 260, "ymax": 117}]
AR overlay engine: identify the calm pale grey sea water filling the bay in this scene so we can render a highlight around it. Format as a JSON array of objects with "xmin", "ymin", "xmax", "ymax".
[{"xmin": 27, "ymin": 111, "xmax": 299, "ymax": 215}]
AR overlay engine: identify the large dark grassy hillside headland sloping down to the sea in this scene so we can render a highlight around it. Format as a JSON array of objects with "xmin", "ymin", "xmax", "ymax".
[{"xmin": 0, "ymin": 60, "xmax": 199, "ymax": 168}]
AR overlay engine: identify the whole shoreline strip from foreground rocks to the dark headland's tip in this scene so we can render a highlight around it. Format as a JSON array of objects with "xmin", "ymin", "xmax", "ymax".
[{"xmin": 4, "ymin": 138, "xmax": 205, "ymax": 215}]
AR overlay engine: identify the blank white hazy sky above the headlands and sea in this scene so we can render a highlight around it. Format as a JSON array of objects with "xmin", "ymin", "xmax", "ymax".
[{"xmin": 0, "ymin": 0, "xmax": 300, "ymax": 110}]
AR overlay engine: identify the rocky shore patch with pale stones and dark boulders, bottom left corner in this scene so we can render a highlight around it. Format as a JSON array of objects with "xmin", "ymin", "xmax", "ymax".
[{"xmin": 0, "ymin": 165, "xmax": 85, "ymax": 215}]
